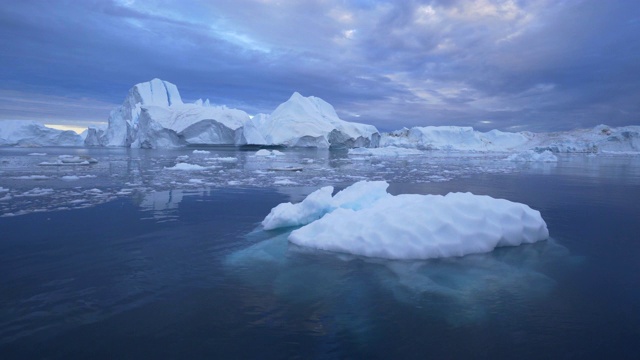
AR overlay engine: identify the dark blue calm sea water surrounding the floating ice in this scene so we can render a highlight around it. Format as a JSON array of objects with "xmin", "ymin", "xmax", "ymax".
[{"xmin": 0, "ymin": 149, "xmax": 640, "ymax": 359}]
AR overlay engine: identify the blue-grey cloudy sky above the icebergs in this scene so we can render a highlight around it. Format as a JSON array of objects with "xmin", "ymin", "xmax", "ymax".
[{"xmin": 0, "ymin": 0, "xmax": 640, "ymax": 131}]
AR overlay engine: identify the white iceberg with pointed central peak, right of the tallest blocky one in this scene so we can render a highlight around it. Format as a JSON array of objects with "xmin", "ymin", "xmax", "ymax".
[{"xmin": 244, "ymin": 92, "xmax": 380, "ymax": 148}]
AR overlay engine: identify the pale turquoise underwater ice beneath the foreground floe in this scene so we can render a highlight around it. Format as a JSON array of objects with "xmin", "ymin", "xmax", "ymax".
[{"xmin": 228, "ymin": 224, "xmax": 582, "ymax": 328}]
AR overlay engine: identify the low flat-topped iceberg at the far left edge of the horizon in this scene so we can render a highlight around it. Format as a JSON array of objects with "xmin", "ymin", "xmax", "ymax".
[{"xmin": 0, "ymin": 120, "xmax": 83, "ymax": 147}]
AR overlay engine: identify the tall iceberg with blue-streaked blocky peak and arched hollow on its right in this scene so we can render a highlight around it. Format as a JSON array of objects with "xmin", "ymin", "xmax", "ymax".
[{"xmin": 95, "ymin": 79, "xmax": 249, "ymax": 148}]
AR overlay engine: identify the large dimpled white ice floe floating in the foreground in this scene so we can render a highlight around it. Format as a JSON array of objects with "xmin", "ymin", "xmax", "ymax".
[{"xmin": 262, "ymin": 181, "xmax": 549, "ymax": 259}]
